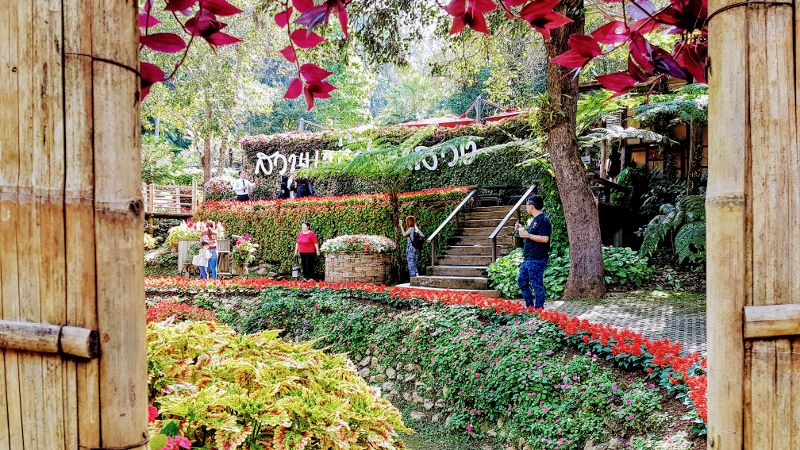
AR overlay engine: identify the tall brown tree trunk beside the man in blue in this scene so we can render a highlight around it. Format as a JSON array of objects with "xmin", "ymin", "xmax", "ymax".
[{"xmin": 542, "ymin": 0, "xmax": 606, "ymax": 298}]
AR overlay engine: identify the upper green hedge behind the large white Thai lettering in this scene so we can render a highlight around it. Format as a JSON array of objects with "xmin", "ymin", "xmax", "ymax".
[{"xmin": 233, "ymin": 116, "xmax": 540, "ymax": 200}]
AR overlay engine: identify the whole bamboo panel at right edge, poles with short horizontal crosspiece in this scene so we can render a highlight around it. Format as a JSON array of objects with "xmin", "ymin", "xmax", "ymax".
[{"xmin": 706, "ymin": 0, "xmax": 800, "ymax": 450}]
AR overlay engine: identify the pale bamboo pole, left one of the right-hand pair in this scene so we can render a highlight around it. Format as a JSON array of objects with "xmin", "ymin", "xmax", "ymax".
[{"xmin": 706, "ymin": 0, "xmax": 749, "ymax": 450}]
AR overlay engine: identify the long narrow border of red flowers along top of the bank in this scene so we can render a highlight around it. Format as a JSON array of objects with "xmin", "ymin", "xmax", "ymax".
[{"xmin": 145, "ymin": 277, "xmax": 707, "ymax": 425}]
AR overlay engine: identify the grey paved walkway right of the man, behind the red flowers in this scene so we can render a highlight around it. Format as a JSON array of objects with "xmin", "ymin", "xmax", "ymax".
[{"xmin": 545, "ymin": 291, "xmax": 706, "ymax": 355}]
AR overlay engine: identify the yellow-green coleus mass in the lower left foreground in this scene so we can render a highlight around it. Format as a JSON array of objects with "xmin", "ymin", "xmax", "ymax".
[{"xmin": 147, "ymin": 322, "xmax": 411, "ymax": 450}]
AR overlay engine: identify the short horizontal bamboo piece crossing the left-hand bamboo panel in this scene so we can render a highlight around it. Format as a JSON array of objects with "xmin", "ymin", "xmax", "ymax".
[{"xmin": 0, "ymin": 320, "xmax": 98, "ymax": 358}]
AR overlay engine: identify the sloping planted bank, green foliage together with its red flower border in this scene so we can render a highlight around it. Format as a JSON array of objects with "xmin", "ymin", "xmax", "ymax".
[{"xmin": 147, "ymin": 279, "xmax": 706, "ymax": 448}]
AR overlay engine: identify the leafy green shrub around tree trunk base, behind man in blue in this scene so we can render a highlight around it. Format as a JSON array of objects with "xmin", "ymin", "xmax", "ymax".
[{"xmin": 489, "ymin": 247, "xmax": 653, "ymax": 299}]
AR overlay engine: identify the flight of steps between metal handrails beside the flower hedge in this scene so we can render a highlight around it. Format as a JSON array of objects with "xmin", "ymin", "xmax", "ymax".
[{"xmin": 409, "ymin": 206, "xmax": 516, "ymax": 297}]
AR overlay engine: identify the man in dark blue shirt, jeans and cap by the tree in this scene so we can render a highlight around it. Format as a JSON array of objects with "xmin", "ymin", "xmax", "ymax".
[{"xmin": 514, "ymin": 195, "xmax": 553, "ymax": 309}]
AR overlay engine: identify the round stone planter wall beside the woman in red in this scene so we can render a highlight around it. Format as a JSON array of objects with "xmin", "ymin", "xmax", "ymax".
[{"xmin": 325, "ymin": 253, "xmax": 392, "ymax": 284}]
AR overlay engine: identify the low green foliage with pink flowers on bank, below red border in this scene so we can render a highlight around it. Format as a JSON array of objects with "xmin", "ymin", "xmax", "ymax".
[{"xmin": 228, "ymin": 288, "xmax": 662, "ymax": 449}]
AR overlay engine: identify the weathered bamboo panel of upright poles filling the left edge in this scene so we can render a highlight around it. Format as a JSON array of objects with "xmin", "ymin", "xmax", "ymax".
[{"xmin": 0, "ymin": 0, "xmax": 147, "ymax": 450}]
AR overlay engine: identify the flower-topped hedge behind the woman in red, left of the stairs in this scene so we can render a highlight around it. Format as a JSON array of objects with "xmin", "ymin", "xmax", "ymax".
[{"xmin": 194, "ymin": 187, "xmax": 467, "ymax": 273}]
